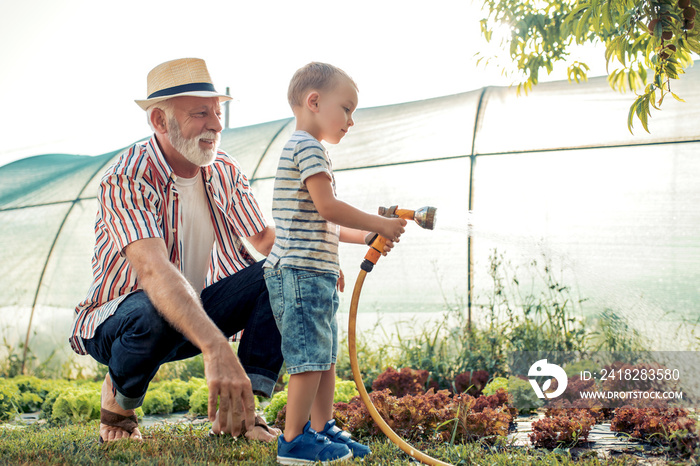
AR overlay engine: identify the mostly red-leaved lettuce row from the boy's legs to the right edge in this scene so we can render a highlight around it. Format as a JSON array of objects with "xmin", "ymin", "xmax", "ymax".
[{"xmin": 265, "ymin": 368, "xmax": 699, "ymax": 457}]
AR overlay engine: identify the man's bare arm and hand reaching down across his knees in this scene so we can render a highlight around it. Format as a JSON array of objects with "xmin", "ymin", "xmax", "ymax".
[{"xmin": 124, "ymin": 238, "xmax": 255, "ymax": 435}]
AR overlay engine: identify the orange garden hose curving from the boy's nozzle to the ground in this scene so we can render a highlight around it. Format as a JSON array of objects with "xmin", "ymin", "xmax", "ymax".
[{"xmin": 348, "ymin": 270, "xmax": 452, "ymax": 466}]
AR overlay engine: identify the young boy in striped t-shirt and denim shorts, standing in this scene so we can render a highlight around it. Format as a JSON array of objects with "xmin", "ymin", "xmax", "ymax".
[{"xmin": 264, "ymin": 63, "xmax": 406, "ymax": 464}]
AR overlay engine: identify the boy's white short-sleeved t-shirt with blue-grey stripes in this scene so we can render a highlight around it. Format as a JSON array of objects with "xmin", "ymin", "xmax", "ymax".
[{"xmin": 264, "ymin": 131, "xmax": 340, "ymax": 272}]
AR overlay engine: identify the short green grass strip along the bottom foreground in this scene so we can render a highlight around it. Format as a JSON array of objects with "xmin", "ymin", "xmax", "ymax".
[{"xmin": 0, "ymin": 421, "xmax": 694, "ymax": 466}]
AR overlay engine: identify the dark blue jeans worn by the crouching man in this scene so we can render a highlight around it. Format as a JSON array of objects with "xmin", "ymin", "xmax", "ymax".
[{"xmin": 85, "ymin": 261, "xmax": 283, "ymax": 409}]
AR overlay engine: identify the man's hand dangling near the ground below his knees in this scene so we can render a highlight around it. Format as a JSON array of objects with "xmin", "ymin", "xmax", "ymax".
[{"xmin": 202, "ymin": 335, "xmax": 255, "ymax": 437}]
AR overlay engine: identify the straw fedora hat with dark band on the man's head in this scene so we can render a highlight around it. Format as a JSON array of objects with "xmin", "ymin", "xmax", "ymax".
[{"xmin": 135, "ymin": 58, "xmax": 231, "ymax": 110}]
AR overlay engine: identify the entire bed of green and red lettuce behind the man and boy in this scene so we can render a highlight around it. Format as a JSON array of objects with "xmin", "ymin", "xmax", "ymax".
[{"xmin": 0, "ymin": 368, "xmax": 699, "ymax": 456}]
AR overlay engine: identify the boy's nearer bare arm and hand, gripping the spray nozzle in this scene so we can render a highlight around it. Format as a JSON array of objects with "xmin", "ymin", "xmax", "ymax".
[{"xmin": 305, "ymin": 173, "xmax": 406, "ymax": 242}]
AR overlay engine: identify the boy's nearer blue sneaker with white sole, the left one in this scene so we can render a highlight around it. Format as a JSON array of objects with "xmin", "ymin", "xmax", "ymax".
[{"xmin": 277, "ymin": 422, "xmax": 352, "ymax": 464}]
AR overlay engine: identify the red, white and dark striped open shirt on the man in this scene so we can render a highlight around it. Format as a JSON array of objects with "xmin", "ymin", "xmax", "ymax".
[{"xmin": 69, "ymin": 136, "xmax": 267, "ymax": 354}]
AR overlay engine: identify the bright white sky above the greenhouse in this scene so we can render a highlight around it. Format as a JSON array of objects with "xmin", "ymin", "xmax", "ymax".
[{"xmin": 0, "ymin": 0, "xmax": 602, "ymax": 165}]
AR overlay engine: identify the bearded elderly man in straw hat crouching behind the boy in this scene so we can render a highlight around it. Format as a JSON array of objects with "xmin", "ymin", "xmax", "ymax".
[{"xmin": 70, "ymin": 58, "xmax": 283, "ymax": 441}]
